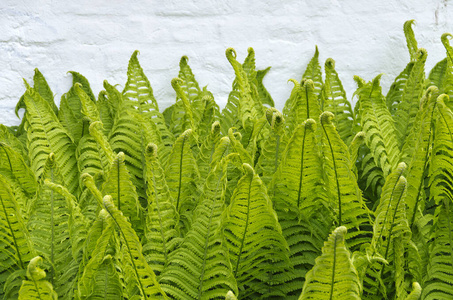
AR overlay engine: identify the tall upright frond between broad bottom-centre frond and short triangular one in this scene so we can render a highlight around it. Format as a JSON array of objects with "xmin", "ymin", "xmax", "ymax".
[{"xmin": 269, "ymin": 119, "xmax": 332, "ymax": 299}]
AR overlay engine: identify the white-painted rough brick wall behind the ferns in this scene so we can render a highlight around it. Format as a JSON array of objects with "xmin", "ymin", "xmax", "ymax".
[{"xmin": 0, "ymin": 0, "xmax": 453, "ymax": 125}]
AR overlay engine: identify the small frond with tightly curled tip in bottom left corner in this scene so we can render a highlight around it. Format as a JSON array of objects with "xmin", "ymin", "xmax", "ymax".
[{"xmin": 19, "ymin": 256, "xmax": 58, "ymax": 300}]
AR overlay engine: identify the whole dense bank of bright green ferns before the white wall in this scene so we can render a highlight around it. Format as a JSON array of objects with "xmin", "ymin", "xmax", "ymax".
[{"xmin": 0, "ymin": 21, "xmax": 453, "ymax": 300}]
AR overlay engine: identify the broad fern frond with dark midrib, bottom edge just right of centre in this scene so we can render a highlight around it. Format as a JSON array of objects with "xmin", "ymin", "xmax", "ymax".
[{"xmin": 222, "ymin": 164, "xmax": 289, "ymax": 298}]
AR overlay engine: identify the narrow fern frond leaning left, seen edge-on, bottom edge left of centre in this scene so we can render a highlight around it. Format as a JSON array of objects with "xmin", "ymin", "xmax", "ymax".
[{"xmin": 103, "ymin": 195, "xmax": 168, "ymax": 299}]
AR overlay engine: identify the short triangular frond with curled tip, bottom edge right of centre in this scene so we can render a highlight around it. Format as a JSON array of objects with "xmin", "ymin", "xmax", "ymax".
[{"xmin": 299, "ymin": 226, "xmax": 362, "ymax": 300}]
